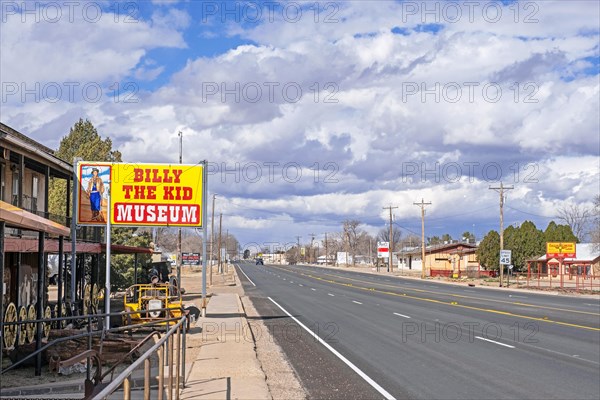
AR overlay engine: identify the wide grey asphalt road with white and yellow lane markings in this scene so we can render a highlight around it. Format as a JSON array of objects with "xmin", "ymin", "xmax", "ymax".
[{"xmin": 236, "ymin": 263, "xmax": 600, "ymax": 399}]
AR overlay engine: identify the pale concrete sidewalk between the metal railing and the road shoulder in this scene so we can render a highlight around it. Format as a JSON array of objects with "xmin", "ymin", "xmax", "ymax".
[{"xmin": 180, "ymin": 266, "xmax": 272, "ymax": 399}]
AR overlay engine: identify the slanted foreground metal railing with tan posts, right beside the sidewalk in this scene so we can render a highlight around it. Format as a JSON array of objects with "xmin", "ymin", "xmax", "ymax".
[{"xmin": 86, "ymin": 316, "xmax": 188, "ymax": 400}]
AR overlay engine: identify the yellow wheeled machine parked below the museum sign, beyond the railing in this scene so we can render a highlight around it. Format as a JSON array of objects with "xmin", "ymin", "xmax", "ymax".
[{"xmin": 123, "ymin": 283, "xmax": 184, "ymax": 325}]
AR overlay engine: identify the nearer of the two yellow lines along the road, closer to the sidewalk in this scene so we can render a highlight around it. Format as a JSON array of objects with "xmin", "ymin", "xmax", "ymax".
[{"xmin": 273, "ymin": 267, "xmax": 600, "ymax": 332}]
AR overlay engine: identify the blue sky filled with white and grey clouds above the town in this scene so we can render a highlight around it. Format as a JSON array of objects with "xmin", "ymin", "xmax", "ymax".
[{"xmin": 0, "ymin": 0, "xmax": 600, "ymax": 250}]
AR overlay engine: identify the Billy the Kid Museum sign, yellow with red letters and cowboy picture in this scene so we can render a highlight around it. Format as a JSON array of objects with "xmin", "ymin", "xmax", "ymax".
[{"xmin": 77, "ymin": 162, "xmax": 204, "ymax": 227}]
